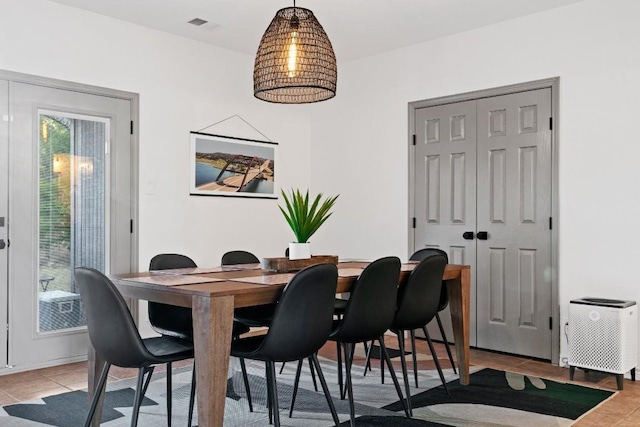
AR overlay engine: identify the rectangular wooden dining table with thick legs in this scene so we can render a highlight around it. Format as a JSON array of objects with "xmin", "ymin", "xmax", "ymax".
[{"xmin": 88, "ymin": 262, "xmax": 471, "ymax": 427}]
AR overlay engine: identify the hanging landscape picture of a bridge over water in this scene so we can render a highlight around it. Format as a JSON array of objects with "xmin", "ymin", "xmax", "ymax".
[{"xmin": 189, "ymin": 132, "xmax": 278, "ymax": 199}]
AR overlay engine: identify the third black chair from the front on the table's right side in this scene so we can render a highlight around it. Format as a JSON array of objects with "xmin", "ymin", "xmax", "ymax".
[{"xmin": 389, "ymin": 254, "xmax": 449, "ymax": 416}]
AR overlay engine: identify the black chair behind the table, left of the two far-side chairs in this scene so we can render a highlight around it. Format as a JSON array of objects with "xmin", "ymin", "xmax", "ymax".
[{"xmin": 148, "ymin": 254, "xmax": 253, "ymax": 418}]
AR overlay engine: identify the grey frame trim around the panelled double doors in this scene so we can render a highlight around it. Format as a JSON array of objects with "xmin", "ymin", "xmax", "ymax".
[{"xmin": 407, "ymin": 77, "xmax": 562, "ymax": 365}]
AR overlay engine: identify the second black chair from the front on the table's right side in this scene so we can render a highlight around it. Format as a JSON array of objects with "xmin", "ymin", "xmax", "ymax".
[{"xmin": 291, "ymin": 257, "xmax": 409, "ymax": 427}]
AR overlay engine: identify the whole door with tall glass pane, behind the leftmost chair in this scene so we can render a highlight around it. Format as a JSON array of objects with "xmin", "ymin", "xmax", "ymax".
[{"xmin": 8, "ymin": 82, "xmax": 133, "ymax": 369}]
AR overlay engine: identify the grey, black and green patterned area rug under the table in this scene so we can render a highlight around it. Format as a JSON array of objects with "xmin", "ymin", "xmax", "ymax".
[{"xmin": 0, "ymin": 358, "xmax": 614, "ymax": 427}]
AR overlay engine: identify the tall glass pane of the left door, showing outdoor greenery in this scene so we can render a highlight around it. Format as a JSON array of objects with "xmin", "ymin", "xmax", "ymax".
[{"xmin": 37, "ymin": 110, "xmax": 110, "ymax": 332}]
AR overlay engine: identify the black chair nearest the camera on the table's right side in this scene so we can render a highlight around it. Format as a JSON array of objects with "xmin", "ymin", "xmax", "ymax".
[{"xmin": 231, "ymin": 264, "xmax": 340, "ymax": 427}]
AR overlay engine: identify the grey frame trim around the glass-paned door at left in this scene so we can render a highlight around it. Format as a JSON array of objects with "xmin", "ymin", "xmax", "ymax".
[{"xmin": 0, "ymin": 69, "xmax": 140, "ymax": 319}]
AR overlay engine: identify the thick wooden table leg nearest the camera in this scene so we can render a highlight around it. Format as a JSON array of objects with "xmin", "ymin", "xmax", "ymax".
[{"xmin": 192, "ymin": 296, "xmax": 234, "ymax": 427}]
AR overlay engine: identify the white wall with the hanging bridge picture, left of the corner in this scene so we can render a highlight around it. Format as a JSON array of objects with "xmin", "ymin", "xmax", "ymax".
[{"xmin": 0, "ymin": 0, "xmax": 310, "ymax": 334}]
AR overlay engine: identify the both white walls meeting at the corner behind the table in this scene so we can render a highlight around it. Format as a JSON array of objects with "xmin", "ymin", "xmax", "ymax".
[{"xmin": 5, "ymin": 0, "xmax": 640, "ymax": 362}]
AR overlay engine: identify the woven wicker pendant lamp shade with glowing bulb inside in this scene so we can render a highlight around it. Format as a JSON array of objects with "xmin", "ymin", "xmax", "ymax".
[{"xmin": 253, "ymin": 3, "xmax": 338, "ymax": 104}]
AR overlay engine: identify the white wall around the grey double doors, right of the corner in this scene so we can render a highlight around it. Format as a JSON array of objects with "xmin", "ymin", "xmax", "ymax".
[{"xmin": 311, "ymin": 0, "xmax": 640, "ymax": 364}]
